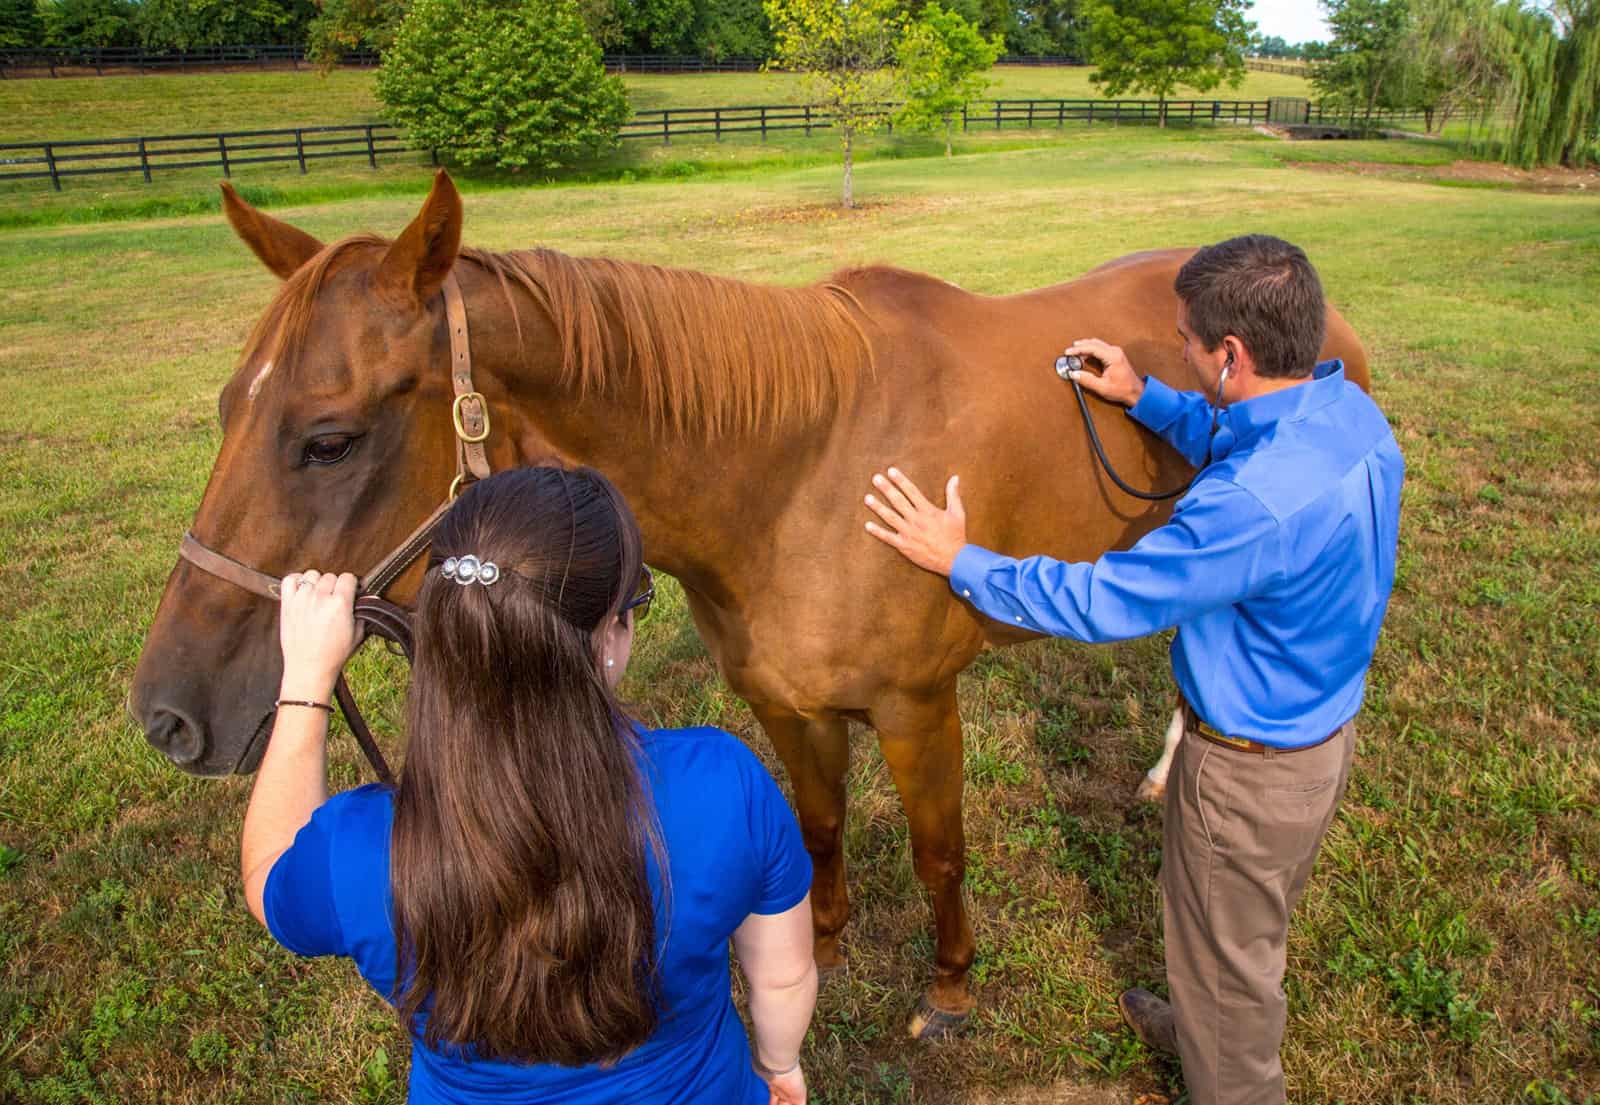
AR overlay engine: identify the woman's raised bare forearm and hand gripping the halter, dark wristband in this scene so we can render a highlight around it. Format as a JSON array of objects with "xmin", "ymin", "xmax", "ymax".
[{"xmin": 238, "ymin": 571, "xmax": 355, "ymax": 924}]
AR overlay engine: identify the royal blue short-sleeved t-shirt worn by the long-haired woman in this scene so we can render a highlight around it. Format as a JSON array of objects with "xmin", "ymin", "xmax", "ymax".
[{"xmin": 264, "ymin": 729, "xmax": 811, "ymax": 1105}]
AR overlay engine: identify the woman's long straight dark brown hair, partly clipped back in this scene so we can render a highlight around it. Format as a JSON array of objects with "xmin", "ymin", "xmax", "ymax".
[{"xmin": 390, "ymin": 469, "xmax": 656, "ymax": 1065}]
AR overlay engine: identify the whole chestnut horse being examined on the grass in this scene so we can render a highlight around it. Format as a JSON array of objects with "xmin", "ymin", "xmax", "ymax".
[{"xmin": 130, "ymin": 173, "xmax": 1366, "ymax": 1035}]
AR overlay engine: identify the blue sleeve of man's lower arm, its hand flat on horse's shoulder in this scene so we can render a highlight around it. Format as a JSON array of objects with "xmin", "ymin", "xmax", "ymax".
[{"xmin": 950, "ymin": 478, "xmax": 1285, "ymax": 643}]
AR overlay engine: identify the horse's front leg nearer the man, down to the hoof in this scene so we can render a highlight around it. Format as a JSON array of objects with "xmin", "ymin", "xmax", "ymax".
[{"xmin": 870, "ymin": 680, "xmax": 976, "ymax": 1039}]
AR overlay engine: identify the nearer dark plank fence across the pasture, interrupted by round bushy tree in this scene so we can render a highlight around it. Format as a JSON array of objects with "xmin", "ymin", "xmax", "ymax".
[{"xmin": 0, "ymin": 99, "xmax": 1432, "ymax": 192}]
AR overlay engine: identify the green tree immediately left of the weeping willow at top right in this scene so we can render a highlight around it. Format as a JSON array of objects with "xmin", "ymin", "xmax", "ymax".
[{"xmin": 1310, "ymin": 0, "xmax": 1414, "ymax": 120}]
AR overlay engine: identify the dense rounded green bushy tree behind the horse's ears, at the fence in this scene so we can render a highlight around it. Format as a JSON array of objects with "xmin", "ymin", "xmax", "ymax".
[{"xmin": 378, "ymin": 0, "xmax": 629, "ymax": 170}]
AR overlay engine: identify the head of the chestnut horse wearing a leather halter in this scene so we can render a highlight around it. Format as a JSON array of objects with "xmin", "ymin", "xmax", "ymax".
[{"xmin": 128, "ymin": 173, "xmax": 461, "ymax": 776}]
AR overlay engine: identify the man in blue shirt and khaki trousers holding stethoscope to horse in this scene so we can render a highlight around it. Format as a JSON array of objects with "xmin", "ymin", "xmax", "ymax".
[{"xmin": 867, "ymin": 235, "xmax": 1405, "ymax": 1105}]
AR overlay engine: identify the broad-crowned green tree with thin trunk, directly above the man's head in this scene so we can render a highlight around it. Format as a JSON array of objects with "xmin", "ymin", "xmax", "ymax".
[{"xmin": 1085, "ymin": 0, "xmax": 1254, "ymax": 126}]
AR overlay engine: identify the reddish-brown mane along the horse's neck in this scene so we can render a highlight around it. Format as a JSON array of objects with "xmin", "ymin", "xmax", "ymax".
[{"xmin": 461, "ymin": 248, "xmax": 874, "ymax": 438}]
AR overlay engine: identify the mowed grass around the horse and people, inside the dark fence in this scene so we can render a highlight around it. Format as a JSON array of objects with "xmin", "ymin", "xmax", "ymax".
[{"xmin": 0, "ymin": 130, "xmax": 1600, "ymax": 1105}]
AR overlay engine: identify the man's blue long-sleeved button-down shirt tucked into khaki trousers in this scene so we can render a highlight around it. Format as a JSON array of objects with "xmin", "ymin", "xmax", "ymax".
[{"xmin": 950, "ymin": 361, "xmax": 1405, "ymax": 747}]
